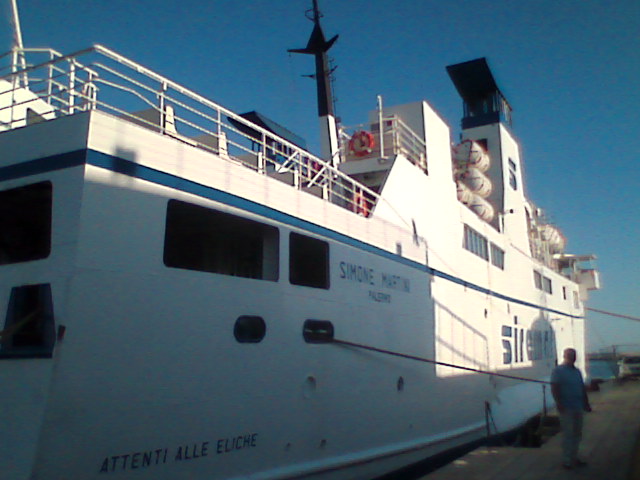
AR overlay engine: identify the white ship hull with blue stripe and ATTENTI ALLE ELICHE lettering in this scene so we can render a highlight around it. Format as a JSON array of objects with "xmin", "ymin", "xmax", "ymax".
[{"xmin": 0, "ymin": 35, "xmax": 596, "ymax": 480}]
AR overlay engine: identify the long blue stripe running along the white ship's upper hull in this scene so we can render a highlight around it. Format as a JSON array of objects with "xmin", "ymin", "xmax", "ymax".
[{"xmin": 0, "ymin": 146, "xmax": 583, "ymax": 318}]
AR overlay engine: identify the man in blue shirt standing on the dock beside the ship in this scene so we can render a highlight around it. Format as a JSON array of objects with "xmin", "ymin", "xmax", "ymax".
[{"xmin": 551, "ymin": 348, "xmax": 591, "ymax": 468}]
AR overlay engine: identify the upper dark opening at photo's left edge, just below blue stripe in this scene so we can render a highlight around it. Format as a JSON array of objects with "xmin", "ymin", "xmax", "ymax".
[{"xmin": 0, "ymin": 182, "xmax": 53, "ymax": 265}]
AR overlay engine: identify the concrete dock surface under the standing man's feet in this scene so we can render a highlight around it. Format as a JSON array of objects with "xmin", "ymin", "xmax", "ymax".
[{"xmin": 420, "ymin": 380, "xmax": 640, "ymax": 480}]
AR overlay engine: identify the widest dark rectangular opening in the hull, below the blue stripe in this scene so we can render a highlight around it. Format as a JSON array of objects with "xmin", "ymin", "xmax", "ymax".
[{"xmin": 164, "ymin": 200, "xmax": 280, "ymax": 281}]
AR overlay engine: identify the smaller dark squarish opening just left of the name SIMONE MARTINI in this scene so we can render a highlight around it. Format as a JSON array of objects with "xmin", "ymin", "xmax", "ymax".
[{"xmin": 289, "ymin": 233, "xmax": 329, "ymax": 289}]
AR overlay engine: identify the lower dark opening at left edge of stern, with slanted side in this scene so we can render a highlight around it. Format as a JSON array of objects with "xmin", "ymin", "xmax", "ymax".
[{"xmin": 0, "ymin": 283, "xmax": 55, "ymax": 358}]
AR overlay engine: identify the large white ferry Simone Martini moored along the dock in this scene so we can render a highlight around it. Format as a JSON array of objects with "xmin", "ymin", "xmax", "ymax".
[{"xmin": 0, "ymin": 0, "xmax": 600, "ymax": 480}]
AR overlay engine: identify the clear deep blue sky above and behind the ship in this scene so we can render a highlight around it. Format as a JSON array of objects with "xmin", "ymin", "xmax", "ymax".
[{"xmin": 0, "ymin": 0, "xmax": 640, "ymax": 350}]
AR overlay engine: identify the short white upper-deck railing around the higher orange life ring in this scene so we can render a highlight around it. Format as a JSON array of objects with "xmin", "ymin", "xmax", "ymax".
[{"xmin": 340, "ymin": 115, "xmax": 427, "ymax": 172}]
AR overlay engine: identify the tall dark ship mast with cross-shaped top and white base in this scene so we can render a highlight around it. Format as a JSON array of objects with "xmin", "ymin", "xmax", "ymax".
[{"xmin": 289, "ymin": 0, "xmax": 340, "ymax": 165}]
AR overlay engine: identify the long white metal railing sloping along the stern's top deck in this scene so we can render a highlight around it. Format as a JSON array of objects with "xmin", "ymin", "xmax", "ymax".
[{"xmin": 0, "ymin": 45, "xmax": 379, "ymax": 216}]
